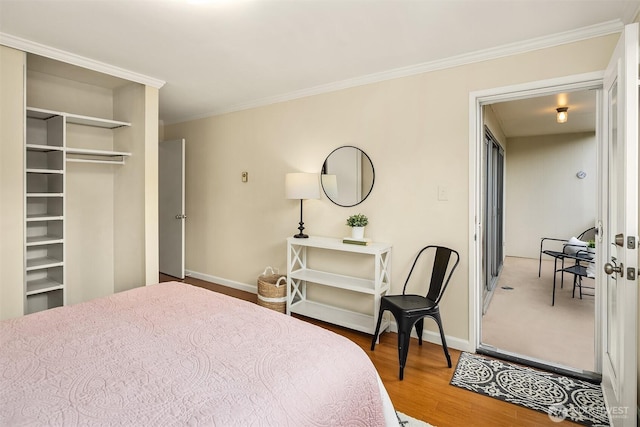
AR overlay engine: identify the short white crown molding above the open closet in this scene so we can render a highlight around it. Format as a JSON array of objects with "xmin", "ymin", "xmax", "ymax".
[{"xmin": 0, "ymin": 32, "xmax": 165, "ymax": 89}]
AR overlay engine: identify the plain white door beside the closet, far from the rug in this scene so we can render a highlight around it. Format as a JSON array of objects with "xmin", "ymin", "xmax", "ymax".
[{"xmin": 158, "ymin": 139, "xmax": 186, "ymax": 279}]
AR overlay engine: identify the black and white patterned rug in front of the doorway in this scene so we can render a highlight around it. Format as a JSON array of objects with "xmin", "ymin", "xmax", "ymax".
[{"xmin": 451, "ymin": 352, "xmax": 609, "ymax": 426}]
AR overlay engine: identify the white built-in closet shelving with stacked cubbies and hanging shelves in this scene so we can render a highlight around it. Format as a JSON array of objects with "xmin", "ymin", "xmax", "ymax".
[{"xmin": 25, "ymin": 107, "xmax": 131, "ymax": 313}]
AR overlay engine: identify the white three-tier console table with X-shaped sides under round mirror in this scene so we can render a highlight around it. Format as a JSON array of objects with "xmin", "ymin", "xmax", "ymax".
[{"xmin": 287, "ymin": 236, "xmax": 391, "ymax": 334}]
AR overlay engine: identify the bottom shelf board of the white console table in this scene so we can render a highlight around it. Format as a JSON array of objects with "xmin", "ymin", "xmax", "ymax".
[{"xmin": 291, "ymin": 301, "xmax": 389, "ymax": 335}]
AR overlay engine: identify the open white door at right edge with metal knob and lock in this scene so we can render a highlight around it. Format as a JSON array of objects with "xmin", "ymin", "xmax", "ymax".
[{"xmin": 598, "ymin": 24, "xmax": 638, "ymax": 426}]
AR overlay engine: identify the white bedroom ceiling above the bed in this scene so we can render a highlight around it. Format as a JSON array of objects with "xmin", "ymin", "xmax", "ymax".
[{"xmin": 0, "ymin": 0, "xmax": 640, "ymax": 127}]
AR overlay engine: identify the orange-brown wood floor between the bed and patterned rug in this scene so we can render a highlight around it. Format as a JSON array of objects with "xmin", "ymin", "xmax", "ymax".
[{"xmin": 160, "ymin": 274, "xmax": 577, "ymax": 427}]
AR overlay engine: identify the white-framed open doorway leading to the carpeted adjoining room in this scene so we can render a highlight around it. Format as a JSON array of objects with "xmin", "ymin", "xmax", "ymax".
[{"xmin": 470, "ymin": 73, "xmax": 602, "ymax": 379}]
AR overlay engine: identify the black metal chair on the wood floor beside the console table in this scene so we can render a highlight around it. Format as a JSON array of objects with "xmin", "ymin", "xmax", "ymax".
[{"xmin": 371, "ymin": 245, "xmax": 460, "ymax": 380}]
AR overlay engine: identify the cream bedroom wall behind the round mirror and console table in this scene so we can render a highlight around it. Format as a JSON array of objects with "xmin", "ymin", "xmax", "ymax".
[{"xmin": 164, "ymin": 35, "xmax": 618, "ymax": 346}]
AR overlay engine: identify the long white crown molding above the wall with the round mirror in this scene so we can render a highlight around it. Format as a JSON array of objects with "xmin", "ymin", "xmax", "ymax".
[{"xmin": 165, "ymin": 20, "xmax": 624, "ymax": 125}]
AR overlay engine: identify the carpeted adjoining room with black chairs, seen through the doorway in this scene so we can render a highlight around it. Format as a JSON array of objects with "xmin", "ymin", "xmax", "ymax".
[{"xmin": 482, "ymin": 90, "xmax": 598, "ymax": 373}]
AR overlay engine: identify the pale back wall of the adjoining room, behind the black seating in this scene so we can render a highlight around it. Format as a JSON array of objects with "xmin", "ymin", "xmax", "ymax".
[{"xmin": 505, "ymin": 133, "xmax": 597, "ymax": 259}]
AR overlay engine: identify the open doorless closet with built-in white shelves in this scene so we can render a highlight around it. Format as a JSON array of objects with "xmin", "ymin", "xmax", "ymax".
[{"xmin": 0, "ymin": 46, "xmax": 158, "ymax": 318}]
